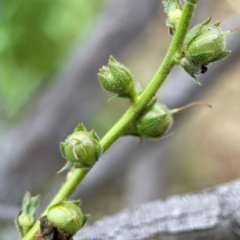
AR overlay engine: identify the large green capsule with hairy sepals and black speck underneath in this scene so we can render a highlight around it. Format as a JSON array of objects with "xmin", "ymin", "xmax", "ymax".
[{"xmin": 178, "ymin": 18, "xmax": 231, "ymax": 84}]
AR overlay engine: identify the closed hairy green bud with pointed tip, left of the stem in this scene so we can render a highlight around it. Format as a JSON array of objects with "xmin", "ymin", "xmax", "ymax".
[{"xmin": 98, "ymin": 56, "xmax": 137, "ymax": 99}]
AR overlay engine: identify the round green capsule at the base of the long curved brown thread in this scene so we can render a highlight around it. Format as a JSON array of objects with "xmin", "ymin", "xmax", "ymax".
[{"xmin": 135, "ymin": 103, "xmax": 173, "ymax": 138}]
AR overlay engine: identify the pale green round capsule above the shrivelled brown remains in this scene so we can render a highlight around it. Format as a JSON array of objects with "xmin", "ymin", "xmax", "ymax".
[{"xmin": 46, "ymin": 201, "xmax": 89, "ymax": 236}]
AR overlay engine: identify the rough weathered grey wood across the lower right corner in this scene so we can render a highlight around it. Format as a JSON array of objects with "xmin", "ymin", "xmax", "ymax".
[{"xmin": 74, "ymin": 180, "xmax": 240, "ymax": 240}]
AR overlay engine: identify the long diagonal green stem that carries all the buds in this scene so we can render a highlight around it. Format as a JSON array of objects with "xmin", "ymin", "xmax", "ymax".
[{"xmin": 22, "ymin": 0, "xmax": 198, "ymax": 240}]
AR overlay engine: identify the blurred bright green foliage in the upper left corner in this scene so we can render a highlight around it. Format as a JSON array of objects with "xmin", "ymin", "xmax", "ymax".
[{"xmin": 0, "ymin": 0, "xmax": 104, "ymax": 121}]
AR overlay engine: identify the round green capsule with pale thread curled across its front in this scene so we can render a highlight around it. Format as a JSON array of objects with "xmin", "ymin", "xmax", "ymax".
[{"xmin": 59, "ymin": 123, "xmax": 102, "ymax": 172}]
